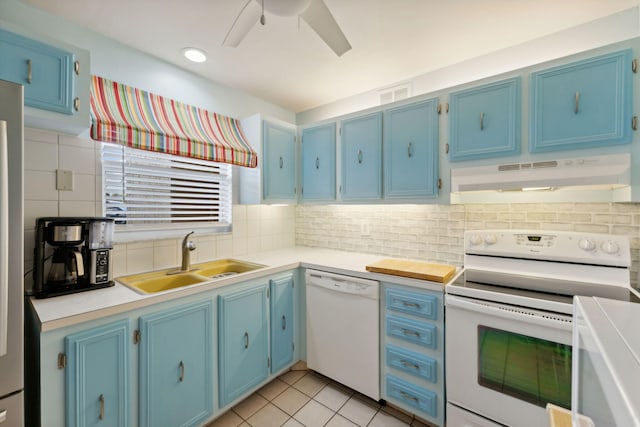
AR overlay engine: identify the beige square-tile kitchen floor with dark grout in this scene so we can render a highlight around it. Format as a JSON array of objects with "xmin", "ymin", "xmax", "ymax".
[{"xmin": 207, "ymin": 371, "xmax": 428, "ymax": 427}]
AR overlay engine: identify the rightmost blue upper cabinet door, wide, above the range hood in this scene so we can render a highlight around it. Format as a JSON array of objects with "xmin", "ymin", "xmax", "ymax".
[{"xmin": 529, "ymin": 49, "xmax": 632, "ymax": 153}]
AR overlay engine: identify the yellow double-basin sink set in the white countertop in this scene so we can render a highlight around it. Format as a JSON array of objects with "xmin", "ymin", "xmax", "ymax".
[{"xmin": 116, "ymin": 258, "xmax": 265, "ymax": 294}]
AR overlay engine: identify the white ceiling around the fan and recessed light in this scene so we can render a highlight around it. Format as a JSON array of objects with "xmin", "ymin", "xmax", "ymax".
[{"xmin": 23, "ymin": 0, "xmax": 639, "ymax": 112}]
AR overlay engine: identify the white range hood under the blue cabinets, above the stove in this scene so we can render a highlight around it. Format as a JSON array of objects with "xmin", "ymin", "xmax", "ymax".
[{"xmin": 451, "ymin": 153, "xmax": 631, "ymax": 203}]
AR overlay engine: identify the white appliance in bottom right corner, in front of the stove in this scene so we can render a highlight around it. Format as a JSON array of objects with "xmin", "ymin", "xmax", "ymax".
[{"xmin": 571, "ymin": 297, "xmax": 640, "ymax": 427}]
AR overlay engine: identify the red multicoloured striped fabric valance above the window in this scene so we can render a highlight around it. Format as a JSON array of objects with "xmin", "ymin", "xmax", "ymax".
[{"xmin": 91, "ymin": 76, "xmax": 258, "ymax": 168}]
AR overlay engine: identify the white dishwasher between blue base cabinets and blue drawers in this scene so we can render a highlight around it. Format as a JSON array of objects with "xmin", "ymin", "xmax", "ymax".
[{"xmin": 305, "ymin": 269, "xmax": 380, "ymax": 400}]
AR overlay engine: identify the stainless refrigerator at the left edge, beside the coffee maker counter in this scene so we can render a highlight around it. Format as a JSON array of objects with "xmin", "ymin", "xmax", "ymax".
[{"xmin": 0, "ymin": 80, "xmax": 24, "ymax": 427}]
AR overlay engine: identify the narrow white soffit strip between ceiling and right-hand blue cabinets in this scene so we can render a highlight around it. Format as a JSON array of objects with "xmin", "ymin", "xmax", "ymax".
[{"xmin": 296, "ymin": 7, "xmax": 640, "ymax": 125}]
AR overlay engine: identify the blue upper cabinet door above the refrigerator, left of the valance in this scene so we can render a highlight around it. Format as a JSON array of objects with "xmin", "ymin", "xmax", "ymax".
[{"xmin": 0, "ymin": 30, "xmax": 75, "ymax": 114}]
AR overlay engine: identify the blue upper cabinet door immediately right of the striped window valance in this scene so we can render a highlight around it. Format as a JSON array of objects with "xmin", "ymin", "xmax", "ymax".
[{"xmin": 262, "ymin": 121, "xmax": 296, "ymax": 202}]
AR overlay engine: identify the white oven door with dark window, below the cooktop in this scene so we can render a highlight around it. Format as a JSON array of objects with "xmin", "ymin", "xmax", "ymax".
[{"xmin": 445, "ymin": 294, "xmax": 572, "ymax": 427}]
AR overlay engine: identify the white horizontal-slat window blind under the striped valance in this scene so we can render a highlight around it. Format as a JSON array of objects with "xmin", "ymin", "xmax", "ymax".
[{"xmin": 102, "ymin": 144, "xmax": 231, "ymax": 237}]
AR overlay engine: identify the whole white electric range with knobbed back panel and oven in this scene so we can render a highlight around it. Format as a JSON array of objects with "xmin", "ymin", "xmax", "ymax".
[{"xmin": 445, "ymin": 230, "xmax": 640, "ymax": 427}]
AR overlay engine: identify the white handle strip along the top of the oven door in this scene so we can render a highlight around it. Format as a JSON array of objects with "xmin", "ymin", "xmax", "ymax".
[{"xmin": 446, "ymin": 294, "xmax": 573, "ymax": 332}]
